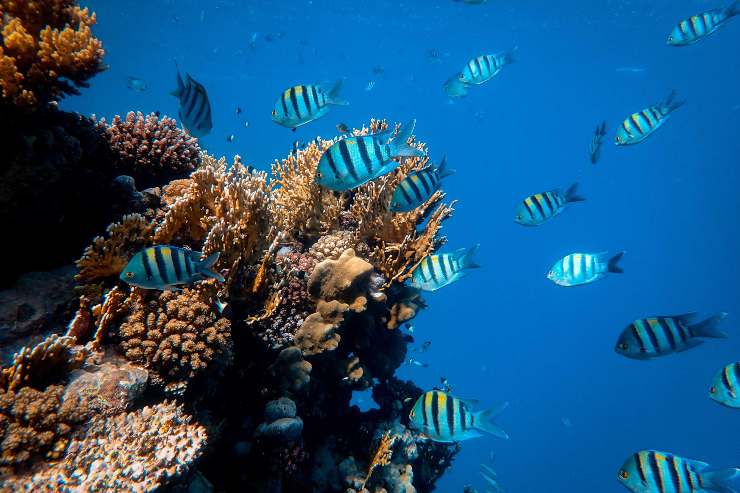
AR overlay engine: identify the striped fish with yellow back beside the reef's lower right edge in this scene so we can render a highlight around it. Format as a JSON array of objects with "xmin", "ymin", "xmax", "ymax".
[{"xmin": 409, "ymin": 390, "xmax": 509, "ymax": 443}]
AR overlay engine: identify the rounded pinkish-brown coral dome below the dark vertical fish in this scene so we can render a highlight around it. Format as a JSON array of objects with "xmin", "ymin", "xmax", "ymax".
[{"xmin": 98, "ymin": 112, "xmax": 201, "ymax": 189}]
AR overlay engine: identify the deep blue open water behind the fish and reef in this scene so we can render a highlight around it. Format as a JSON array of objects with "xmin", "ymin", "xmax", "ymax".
[{"xmin": 64, "ymin": 0, "xmax": 740, "ymax": 493}]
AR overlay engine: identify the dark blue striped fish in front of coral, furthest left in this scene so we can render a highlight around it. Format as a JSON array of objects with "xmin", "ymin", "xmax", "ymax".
[{"xmin": 120, "ymin": 245, "xmax": 224, "ymax": 291}]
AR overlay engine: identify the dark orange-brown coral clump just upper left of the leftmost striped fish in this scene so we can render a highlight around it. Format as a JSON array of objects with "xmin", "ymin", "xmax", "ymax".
[{"xmin": 75, "ymin": 214, "xmax": 152, "ymax": 282}]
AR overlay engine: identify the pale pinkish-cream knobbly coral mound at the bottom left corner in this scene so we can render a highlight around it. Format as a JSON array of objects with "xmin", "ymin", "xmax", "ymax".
[{"xmin": 0, "ymin": 402, "xmax": 207, "ymax": 493}]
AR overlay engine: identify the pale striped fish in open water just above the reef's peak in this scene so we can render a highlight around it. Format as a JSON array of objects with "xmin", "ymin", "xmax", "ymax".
[{"xmin": 272, "ymin": 80, "xmax": 349, "ymax": 130}]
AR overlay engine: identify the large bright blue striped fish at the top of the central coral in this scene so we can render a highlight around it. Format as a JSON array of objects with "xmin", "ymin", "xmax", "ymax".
[{"xmin": 316, "ymin": 120, "xmax": 424, "ymax": 192}]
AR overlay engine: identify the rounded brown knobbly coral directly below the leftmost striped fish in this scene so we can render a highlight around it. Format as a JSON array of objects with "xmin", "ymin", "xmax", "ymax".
[{"xmin": 118, "ymin": 285, "xmax": 231, "ymax": 382}]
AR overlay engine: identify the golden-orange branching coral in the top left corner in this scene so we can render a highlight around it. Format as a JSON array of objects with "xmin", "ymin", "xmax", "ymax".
[{"xmin": 0, "ymin": 0, "xmax": 105, "ymax": 108}]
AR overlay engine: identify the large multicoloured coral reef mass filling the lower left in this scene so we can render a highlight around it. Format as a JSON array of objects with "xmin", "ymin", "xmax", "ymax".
[{"xmin": 0, "ymin": 120, "xmax": 458, "ymax": 493}]
